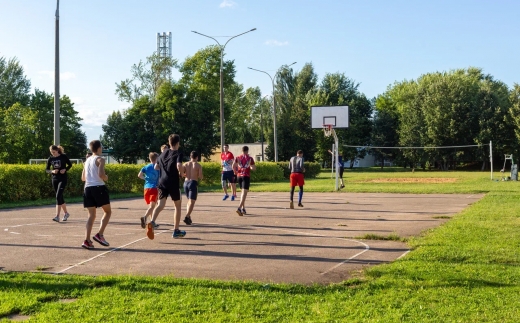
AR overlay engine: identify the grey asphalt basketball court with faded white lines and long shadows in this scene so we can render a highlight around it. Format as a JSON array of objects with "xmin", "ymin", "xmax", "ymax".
[{"xmin": 0, "ymin": 192, "xmax": 483, "ymax": 284}]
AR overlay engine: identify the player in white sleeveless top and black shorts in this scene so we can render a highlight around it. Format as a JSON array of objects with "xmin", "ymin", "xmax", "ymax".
[{"xmin": 81, "ymin": 140, "xmax": 112, "ymax": 249}]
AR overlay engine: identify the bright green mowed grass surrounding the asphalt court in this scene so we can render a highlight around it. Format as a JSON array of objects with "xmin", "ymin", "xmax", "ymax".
[{"xmin": 0, "ymin": 169, "xmax": 520, "ymax": 322}]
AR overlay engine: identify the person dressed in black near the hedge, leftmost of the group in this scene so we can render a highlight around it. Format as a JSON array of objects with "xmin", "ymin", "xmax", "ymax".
[{"xmin": 45, "ymin": 145, "xmax": 72, "ymax": 222}]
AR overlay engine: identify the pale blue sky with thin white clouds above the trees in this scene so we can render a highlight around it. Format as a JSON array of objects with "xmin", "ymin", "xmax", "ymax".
[{"xmin": 0, "ymin": 0, "xmax": 520, "ymax": 141}]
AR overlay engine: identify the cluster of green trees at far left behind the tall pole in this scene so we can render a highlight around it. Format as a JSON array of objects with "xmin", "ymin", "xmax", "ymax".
[{"xmin": 0, "ymin": 57, "xmax": 87, "ymax": 164}]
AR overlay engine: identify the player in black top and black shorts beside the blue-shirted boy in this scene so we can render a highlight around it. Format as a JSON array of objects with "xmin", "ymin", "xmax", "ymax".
[{"xmin": 146, "ymin": 134, "xmax": 186, "ymax": 239}]
